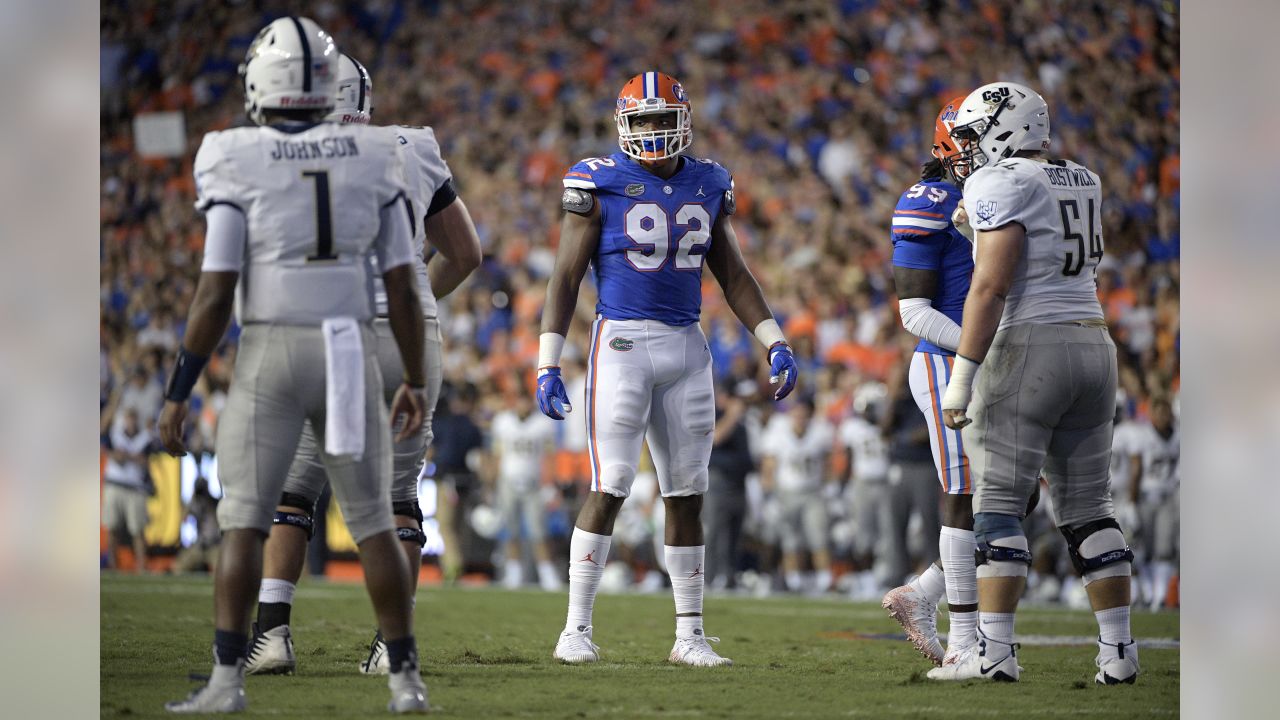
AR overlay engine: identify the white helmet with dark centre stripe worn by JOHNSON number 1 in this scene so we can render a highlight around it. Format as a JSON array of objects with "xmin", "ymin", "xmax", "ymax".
[{"xmin": 239, "ymin": 17, "xmax": 338, "ymax": 124}]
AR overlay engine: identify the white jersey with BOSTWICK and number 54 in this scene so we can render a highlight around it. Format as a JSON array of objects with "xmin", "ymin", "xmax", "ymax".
[{"xmin": 964, "ymin": 158, "xmax": 1102, "ymax": 329}]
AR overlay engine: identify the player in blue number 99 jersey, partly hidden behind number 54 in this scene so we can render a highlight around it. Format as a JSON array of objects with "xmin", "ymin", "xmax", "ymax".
[{"xmin": 882, "ymin": 96, "xmax": 978, "ymax": 665}]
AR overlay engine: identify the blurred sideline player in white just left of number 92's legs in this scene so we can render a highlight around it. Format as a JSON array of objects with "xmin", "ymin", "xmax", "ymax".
[{"xmin": 489, "ymin": 393, "xmax": 561, "ymax": 591}]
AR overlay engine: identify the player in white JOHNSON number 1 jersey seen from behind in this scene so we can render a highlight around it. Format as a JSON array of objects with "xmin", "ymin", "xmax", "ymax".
[{"xmin": 159, "ymin": 17, "xmax": 428, "ymax": 714}]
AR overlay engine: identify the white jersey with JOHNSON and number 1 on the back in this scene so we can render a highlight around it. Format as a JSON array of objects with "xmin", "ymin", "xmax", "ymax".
[{"xmin": 195, "ymin": 123, "xmax": 410, "ymax": 325}]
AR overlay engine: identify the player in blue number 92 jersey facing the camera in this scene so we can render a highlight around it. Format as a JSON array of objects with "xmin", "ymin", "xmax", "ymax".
[{"xmin": 538, "ymin": 72, "xmax": 797, "ymax": 666}]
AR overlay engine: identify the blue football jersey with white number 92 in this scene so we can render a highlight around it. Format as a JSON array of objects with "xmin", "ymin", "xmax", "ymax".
[{"xmin": 564, "ymin": 152, "xmax": 733, "ymax": 327}]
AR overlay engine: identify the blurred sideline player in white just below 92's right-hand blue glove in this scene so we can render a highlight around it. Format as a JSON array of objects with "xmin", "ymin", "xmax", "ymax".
[{"xmin": 760, "ymin": 397, "xmax": 838, "ymax": 593}]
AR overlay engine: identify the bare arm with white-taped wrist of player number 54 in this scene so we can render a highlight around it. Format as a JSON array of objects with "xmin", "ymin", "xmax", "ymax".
[{"xmin": 942, "ymin": 223, "xmax": 1027, "ymax": 430}]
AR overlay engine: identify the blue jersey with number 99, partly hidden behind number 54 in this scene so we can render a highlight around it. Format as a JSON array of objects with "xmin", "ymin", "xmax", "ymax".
[{"xmin": 892, "ymin": 181, "xmax": 973, "ymax": 355}]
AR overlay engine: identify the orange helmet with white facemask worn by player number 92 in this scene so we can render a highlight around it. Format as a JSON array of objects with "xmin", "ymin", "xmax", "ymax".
[{"xmin": 613, "ymin": 72, "xmax": 694, "ymax": 163}]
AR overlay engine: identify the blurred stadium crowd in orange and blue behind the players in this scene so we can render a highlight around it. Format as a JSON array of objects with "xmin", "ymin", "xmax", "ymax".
[{"xmin": 99, "ymin": 0, "xmax": 1179, "ymax": 600}]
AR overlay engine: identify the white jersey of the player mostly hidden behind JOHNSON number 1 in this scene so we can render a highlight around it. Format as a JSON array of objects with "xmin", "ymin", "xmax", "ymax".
[{"xmin": 370, "ymin": 126, "xmax": 452, "ymax": 318}]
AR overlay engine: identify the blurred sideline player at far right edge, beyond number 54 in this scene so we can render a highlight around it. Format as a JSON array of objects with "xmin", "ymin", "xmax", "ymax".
[{"xmin": 1128, "ymin": 397, "xmax": 1181, "ymax": 610}]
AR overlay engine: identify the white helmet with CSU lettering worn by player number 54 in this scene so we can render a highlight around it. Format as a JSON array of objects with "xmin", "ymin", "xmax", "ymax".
[{"xmin": 951, "ymin": 82, "xmax": 1050, "ymax": 179}]
